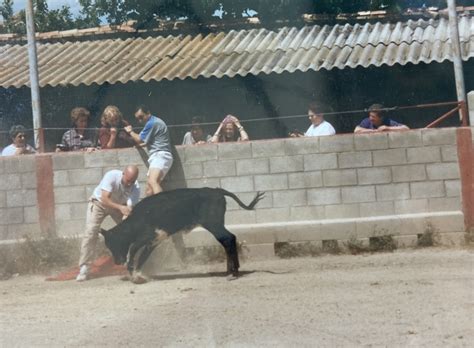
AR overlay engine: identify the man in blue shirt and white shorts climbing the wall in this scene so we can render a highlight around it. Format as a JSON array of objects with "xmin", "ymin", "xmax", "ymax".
[{"xmin": 124, "ymin": 105, "xmax": 173, "ymax": 196}]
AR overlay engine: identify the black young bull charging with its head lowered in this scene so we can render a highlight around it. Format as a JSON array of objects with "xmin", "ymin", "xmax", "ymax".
[{"xmin": 101, "ymin": 187, "xmax": 264, "ymax": 277}]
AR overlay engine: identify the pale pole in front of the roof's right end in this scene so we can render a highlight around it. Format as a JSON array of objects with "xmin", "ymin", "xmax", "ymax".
[{"xmin": 448, "ymin": 0, "xmax": 468, "ymax": 125}]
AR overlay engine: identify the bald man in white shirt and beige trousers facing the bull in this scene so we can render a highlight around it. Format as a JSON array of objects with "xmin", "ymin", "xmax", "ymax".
[{"xmin": 76, "ymin": 166, "xmax": 140, "ymax": 281}]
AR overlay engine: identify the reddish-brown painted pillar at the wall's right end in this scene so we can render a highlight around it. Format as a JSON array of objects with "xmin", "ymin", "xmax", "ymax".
[{"xmin": 456, "ymin": 127, "xmax": 474, "ymax": 229}]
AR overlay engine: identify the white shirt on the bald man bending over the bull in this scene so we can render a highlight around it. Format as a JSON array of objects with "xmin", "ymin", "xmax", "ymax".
[{"xmin": 92, "ymin": 169, "xmax": 140, "ymax": 205}]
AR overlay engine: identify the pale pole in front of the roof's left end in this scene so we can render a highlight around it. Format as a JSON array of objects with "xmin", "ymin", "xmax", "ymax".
[{"xmin": 26, "ymin": 0, "xmax": 44, "ymax": 152}]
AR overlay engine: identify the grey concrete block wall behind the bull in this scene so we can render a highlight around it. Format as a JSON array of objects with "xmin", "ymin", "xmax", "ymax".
[{"xmin": 0, "ymin": 128, "xmax": 471, "ymax": 254}]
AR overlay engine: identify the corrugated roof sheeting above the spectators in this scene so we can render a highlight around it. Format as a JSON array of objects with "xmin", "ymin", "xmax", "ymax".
[{"xmin": 0, "ymin": 16, "xmax": 474, "ymax": 88}]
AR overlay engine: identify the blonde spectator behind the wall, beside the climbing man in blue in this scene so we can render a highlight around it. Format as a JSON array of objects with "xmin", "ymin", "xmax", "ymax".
[{"xmin": 99, "ymin": 105, "xmax": 134, "ymax": 149}]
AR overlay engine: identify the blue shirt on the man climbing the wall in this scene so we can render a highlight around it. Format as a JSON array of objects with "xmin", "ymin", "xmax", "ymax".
[{"xmin": 140, "ymin": 116, "xmax": 171, "ymax": 155}]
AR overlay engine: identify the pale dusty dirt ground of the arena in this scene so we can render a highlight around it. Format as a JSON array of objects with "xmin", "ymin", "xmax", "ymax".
[{"xmin": 0, "ymin": 248, "xmax": 474, "ymax": 347}]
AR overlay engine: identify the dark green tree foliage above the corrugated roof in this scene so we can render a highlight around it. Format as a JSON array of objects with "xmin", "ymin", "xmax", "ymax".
[{"xmin": 0, "ymin": 0, "xmax": 466, "ymax": 32}]
